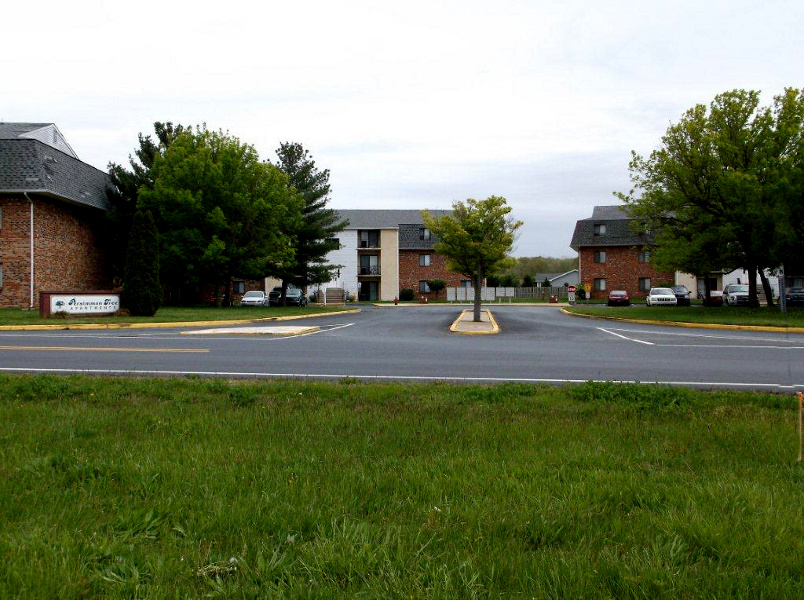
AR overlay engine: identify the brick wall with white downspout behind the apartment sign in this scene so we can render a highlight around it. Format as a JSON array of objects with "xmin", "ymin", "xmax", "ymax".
[{"xmin": 0, "ymin": 195, "xmax": 112, "ymax": 307}]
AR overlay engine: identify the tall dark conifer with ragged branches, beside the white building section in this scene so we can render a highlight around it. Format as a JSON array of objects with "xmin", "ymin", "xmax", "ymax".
[{"xmin": 275, "ymin": 142, "xmax": 346, "ymax": 305}]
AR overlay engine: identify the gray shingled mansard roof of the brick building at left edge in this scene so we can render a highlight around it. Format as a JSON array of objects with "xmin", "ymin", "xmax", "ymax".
[{"xmin": 0, "ymin": 138, "xmax": 109, "ymax": 210}]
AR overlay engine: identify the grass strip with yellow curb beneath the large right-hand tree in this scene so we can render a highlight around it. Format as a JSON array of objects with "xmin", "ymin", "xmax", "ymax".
[{"xmin": 568, "ymin": 305, "xmax": 804, "ymax": 328}]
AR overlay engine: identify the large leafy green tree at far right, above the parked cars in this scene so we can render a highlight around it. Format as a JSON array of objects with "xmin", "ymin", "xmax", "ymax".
[{"xmin": 620, "ymin": 90, "xmax": 802, "ymax": 306}]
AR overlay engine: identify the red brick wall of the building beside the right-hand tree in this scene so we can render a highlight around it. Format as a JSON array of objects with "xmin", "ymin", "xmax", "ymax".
[{"xmin": 580, "ymin": 246, "xmax": 673, "ymax": 298}]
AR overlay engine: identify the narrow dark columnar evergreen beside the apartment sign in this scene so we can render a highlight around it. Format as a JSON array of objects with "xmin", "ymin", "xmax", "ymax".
[{"xmin": 123, "ymin": 211, "xmax": 162, "ymax": 317}]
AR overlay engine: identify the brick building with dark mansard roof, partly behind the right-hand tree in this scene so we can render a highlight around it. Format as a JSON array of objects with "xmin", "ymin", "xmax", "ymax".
[{"xmin": 570, "ymin": 205, "xmax": 675, "ymax": 298}]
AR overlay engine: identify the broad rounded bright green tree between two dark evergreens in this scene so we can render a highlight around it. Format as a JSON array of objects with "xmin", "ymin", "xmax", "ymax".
[{"xmin": 140, "ymin": 128, "xmax": 304, "ymax": 300}]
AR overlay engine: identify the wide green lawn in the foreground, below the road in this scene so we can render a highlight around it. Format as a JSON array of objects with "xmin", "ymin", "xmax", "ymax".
[{"xmin": 0, "ymin": 376, "xmax": 804, "ymax": 598}]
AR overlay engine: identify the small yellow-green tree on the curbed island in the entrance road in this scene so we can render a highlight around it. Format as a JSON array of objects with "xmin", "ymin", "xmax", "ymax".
[{"xmin": 422, "ymin": 196, "xmax": 522, "ymax": 322}]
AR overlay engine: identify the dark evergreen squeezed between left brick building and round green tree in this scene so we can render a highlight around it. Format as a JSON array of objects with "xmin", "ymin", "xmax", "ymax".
[{"xmin": 106, "ymin": 121, "xmax": 186, "ymax": 280}]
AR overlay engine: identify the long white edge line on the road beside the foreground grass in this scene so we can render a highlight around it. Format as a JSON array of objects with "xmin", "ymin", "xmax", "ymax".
[{"xmin": 0, "ymin": 367, "xmax": 804, "ymax": 390}]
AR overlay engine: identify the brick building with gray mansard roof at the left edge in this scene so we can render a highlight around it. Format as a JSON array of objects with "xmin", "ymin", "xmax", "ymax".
[{"xmin": 0, "ymin": 123, "xmax": 112, "ymax": 307}]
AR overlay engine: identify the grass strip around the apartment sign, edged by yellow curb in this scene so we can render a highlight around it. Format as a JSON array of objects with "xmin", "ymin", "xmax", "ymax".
[{"xmin": 0, "ymin": 306, "xmax": 353, "ymax": 325}]
